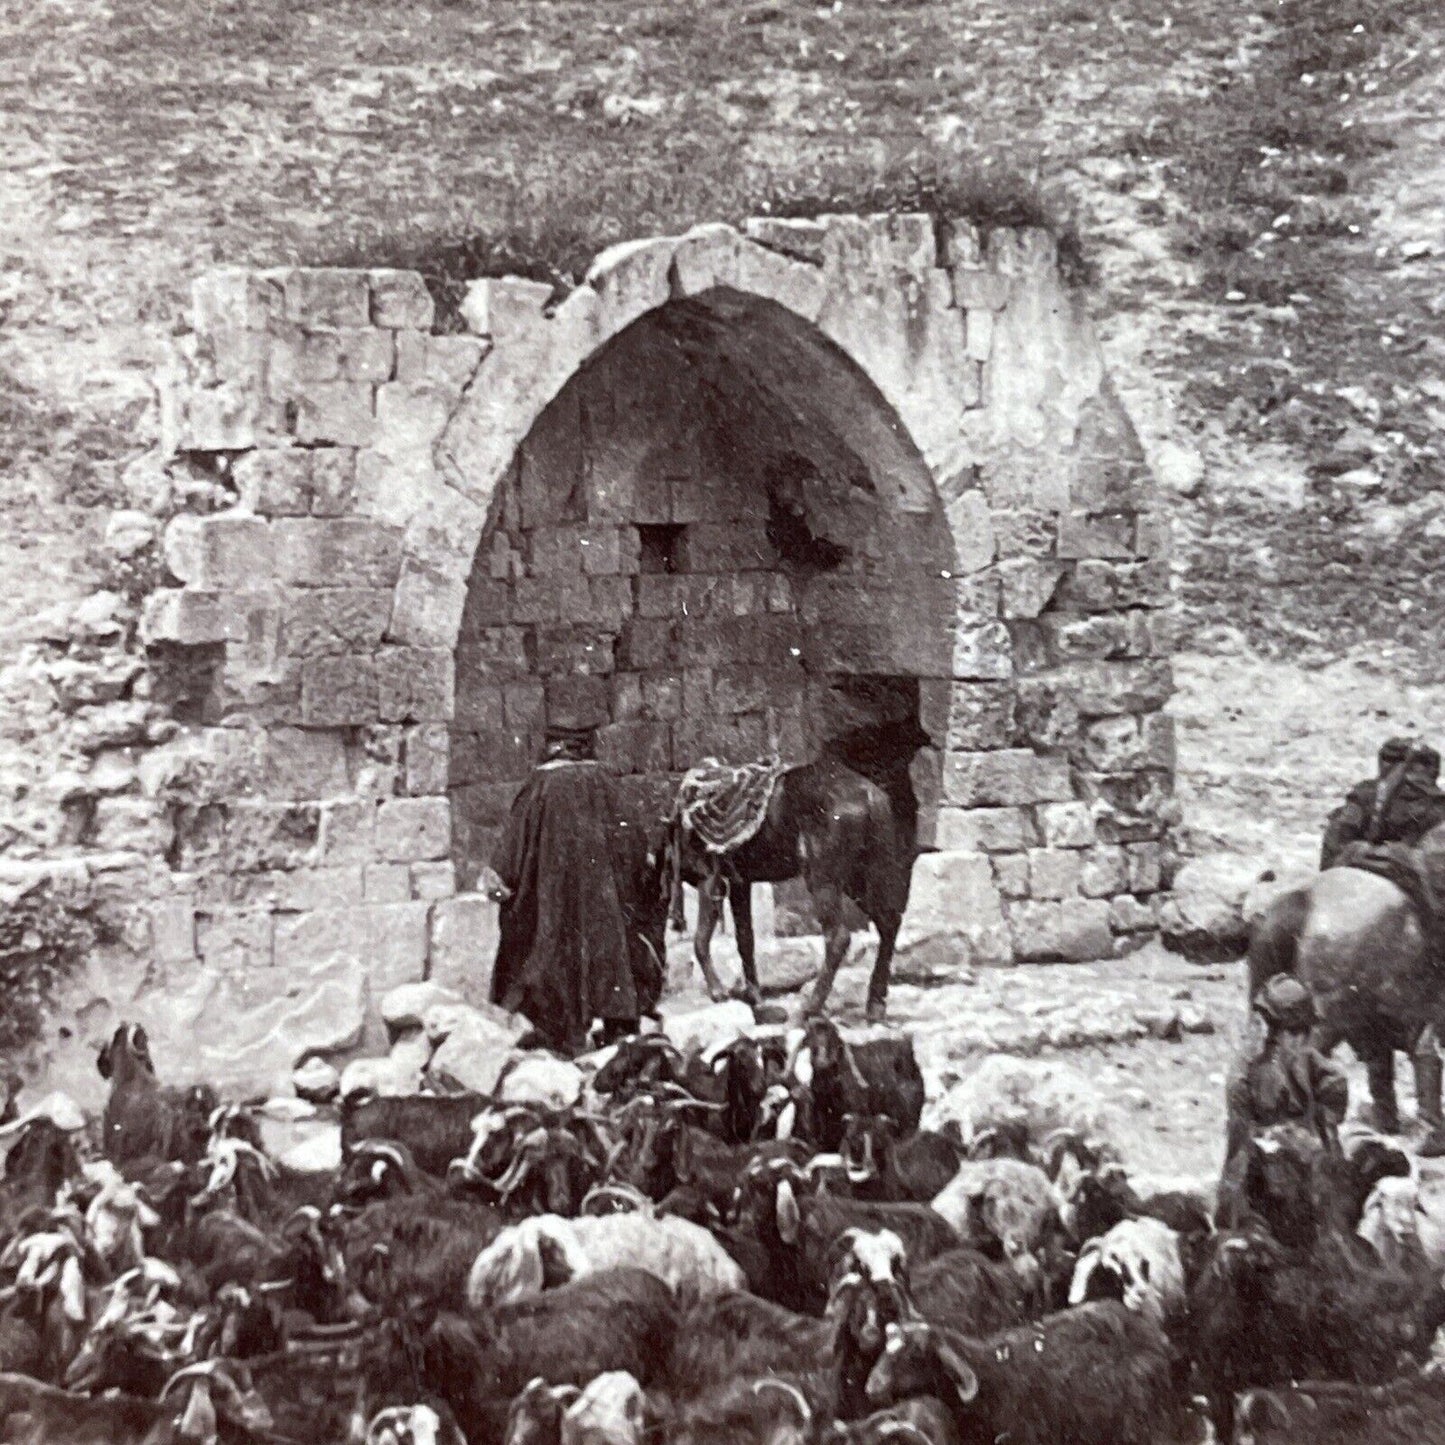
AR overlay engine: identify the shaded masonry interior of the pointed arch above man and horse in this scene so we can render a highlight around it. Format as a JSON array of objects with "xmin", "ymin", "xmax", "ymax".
[{"xmin": 449, "ymin": 286, "xmax": 958, "ymax": 887}]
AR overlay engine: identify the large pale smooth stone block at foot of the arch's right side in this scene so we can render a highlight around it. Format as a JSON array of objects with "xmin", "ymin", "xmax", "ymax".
[{"xmin": 896, "ymin": 853, "xmax": 1010, "ymax": 978}]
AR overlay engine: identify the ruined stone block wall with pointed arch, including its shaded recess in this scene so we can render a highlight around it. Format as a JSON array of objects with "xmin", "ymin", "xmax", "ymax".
[{"xmin": 0, "ymin": 215, "xmax": 1173, "ymax": 1082}]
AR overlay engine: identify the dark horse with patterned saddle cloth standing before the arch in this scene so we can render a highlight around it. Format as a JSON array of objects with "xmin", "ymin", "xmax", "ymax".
[{"xmin": 660, "ymin": 724, "xmax": 928, "ymax": 1022}]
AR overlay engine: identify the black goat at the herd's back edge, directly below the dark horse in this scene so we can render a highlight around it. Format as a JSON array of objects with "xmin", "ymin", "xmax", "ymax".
[{"xmin": 789, "ymin": 1019, "xmax": 925, "ymax": 1153}]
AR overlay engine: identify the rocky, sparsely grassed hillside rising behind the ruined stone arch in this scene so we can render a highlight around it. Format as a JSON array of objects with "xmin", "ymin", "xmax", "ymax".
[{"xmin": 0, "ymin": 0, "xmax": 1445, "ymax": 857}]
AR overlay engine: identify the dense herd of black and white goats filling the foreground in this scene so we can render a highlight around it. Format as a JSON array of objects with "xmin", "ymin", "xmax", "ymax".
[{"xmin": 0, "ymin": 1019, "xmax": 1445, "ymax": 1445}]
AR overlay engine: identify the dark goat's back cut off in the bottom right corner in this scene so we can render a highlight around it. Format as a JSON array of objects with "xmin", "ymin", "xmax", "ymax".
[{"xmin": 1234, "ymin": 1374, "xmax": 1445, "ymax": 1445}]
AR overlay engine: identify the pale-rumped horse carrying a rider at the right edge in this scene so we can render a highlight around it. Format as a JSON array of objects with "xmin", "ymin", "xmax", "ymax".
[{"xmin": 1248, "ymin": 824, "xmax": 1445, "ymax": 1153}]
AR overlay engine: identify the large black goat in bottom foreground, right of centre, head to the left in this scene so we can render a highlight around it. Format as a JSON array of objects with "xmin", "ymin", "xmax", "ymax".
[{"xmin": 868, "ymin": 1301, "xmax": 1198, "ymax": 1445}]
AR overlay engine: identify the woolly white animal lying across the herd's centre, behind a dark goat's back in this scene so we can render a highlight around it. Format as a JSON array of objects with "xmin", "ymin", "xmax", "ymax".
[{"xmin": 467, "ymin": 1214, "xmax": 747, "ymax": 1311}]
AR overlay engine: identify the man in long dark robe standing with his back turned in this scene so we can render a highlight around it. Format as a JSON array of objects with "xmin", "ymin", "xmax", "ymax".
[{"xmin": 490, "ymin": 730, "xmax": 666, "ymax": 1053}]
